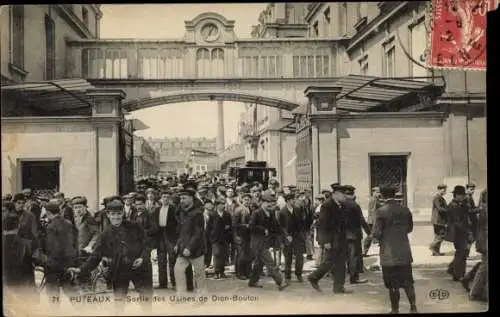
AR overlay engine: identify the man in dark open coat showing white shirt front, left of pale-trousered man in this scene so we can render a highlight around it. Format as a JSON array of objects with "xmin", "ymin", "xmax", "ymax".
[{"xmin": 153, "ymin": 190, "xmax": 178, "ymax": 288}]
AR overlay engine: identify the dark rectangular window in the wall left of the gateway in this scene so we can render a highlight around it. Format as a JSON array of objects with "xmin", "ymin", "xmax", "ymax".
[{"xmin": 21, "ymin": 160, "xmax": 60, "ymax": 196}]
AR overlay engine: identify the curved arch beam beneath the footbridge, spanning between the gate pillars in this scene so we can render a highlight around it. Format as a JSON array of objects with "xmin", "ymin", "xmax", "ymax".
[{"xmin": 122, "ymin": 90, "xmax": 299, "ymax": 111}]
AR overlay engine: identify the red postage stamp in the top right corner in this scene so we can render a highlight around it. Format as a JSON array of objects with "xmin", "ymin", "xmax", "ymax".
[{"xmin": 429, "ymin": 0, "xmax": 496, "ymax": 70}]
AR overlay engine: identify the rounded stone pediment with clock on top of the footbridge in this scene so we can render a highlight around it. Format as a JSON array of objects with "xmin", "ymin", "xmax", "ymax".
[{"xmin": 184, "ymin": 12, "xmax": 236, "ymax": 45}]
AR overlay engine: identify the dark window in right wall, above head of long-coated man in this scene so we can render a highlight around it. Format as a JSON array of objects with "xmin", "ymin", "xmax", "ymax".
[{"xmin": 370, "ymin": 155, "xmax": 408, "ymax": 204}]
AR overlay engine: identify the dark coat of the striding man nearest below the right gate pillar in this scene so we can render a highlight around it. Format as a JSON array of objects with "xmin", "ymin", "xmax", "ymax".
[{"xmin": 317, "ymin": 199, "xmax": 348, "ymax": 249}]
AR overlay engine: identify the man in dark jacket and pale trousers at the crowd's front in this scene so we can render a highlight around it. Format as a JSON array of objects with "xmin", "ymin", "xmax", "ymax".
[{"xmin": 174, "ymin": 187, "xmax": 206, "ymax": 294}]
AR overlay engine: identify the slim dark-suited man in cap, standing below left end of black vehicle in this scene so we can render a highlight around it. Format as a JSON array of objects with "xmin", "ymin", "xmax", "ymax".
[{"xmin": 232, "ymin": 192, "xmax": 252, "ymax": 280}]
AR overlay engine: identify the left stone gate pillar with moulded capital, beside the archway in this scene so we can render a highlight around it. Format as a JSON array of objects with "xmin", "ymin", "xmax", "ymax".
[{"xmin": 88, "ymin": 89, "xmax": 125, "ymax": 210}]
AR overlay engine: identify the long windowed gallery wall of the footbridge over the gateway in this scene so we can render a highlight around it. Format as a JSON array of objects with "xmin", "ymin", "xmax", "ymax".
[{"xmin": 68, "ymin": 40, "xmax": 336, "ymax": 80}]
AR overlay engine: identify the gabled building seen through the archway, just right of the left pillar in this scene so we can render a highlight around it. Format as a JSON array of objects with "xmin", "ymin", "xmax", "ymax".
[{"xmin": 134, "ymin": 135, "xmax": 160, "ymax": 177}]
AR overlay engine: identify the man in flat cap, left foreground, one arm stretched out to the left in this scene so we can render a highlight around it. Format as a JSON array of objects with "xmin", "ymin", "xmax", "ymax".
[{"xmin": 68, "ymin": 199, "xmax": 153, "ymax": 313}]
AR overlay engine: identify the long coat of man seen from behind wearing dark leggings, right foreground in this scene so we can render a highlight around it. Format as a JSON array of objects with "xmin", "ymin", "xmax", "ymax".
[{"xmin": 372, "ymin": 200, "xmax": 413, "ymax": 266}]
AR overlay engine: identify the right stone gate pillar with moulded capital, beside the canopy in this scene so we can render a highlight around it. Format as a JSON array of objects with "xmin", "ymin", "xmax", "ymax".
[{"xmin": 304, "ymin": 86, "xmax": 342, "ymax": 193}]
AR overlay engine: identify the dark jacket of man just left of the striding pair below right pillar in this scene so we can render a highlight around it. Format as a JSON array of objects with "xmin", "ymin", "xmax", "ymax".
[{"xmin": 279, "ymin": 206, "xmax": 308, "ymax": 253}]
